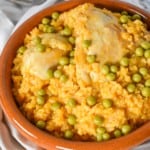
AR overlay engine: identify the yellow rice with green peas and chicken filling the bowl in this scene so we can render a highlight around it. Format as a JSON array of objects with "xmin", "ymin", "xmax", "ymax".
[{"xmin": 12, "ymin": 3, "xmax": 150, "ymax": 141}]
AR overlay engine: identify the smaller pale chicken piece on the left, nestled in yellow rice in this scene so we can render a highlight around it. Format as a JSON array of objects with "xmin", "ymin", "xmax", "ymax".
[{"xmin": 21, "ymin": 50, "xmax": 63, "ymax": 80}]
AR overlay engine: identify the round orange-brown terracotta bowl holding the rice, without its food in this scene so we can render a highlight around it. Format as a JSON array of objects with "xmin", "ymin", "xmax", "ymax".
[{"xmin": 0, "ymin": 0, "xmax": 150, "ymax": 150}]
